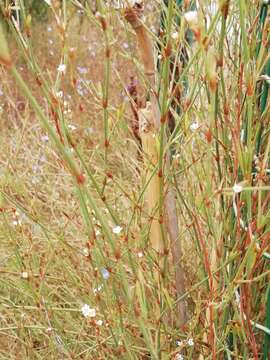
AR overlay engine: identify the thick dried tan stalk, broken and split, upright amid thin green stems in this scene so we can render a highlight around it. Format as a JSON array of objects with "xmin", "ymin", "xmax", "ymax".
[{"xmin": 125, "ymin": 4, "xmax": 187, "ymax": 325}]
